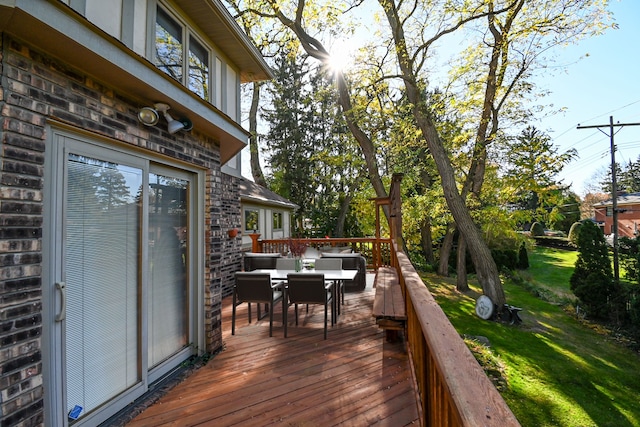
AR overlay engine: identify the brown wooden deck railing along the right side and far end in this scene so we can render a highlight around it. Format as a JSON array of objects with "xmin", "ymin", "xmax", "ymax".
[{"xmin": 250, "ymin": 239, "xmax": 520, "ymax": 427}]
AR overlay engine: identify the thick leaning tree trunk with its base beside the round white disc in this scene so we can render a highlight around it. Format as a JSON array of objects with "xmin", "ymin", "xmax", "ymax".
[{"xmin": 379, "ymin": 0, "xmax": 506, "ymax": 307}]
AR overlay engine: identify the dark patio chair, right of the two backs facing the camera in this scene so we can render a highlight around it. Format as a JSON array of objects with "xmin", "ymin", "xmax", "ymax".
[{"xmin": 282, "ymin": 273, "xmax": 335, "ymax": 340}]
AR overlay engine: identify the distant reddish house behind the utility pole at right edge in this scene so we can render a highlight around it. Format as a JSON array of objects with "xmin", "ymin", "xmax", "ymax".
[{"xmin": 593, "ymin": 193, "xmax": 640, "ymax": 238}]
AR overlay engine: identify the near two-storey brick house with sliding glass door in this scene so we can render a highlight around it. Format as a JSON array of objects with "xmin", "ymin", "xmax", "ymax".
[{"xmin": 0, "ymin": 0, "xmax": 272, "ymax": 426}]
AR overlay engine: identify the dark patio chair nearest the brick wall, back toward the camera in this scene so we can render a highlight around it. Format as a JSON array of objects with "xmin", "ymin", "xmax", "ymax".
[{"xmin": 231, "ymin": 272, "xmax": 284, "ymax": 337}]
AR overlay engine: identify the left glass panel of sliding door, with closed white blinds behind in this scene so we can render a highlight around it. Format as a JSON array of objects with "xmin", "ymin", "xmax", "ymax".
[{"xmin": 64, "ymin": 153, "xmax": 143, "ymax": 415}]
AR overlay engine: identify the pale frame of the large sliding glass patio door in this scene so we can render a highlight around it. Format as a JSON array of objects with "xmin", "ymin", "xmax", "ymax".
[{"xmin": 42, "ymin": 127, "xmax": 205, "ymax": 426}]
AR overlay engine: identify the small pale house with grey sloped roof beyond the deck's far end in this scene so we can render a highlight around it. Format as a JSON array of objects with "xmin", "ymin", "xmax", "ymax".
[{"xmin": 240, "ymin": 179, "xmax": 298, "ymax": 250}]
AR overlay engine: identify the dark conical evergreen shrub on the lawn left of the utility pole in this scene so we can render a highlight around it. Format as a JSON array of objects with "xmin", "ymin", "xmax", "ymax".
[{"xmin": 569, "ymin": 221, "xmax": 615, "ymax": 319}]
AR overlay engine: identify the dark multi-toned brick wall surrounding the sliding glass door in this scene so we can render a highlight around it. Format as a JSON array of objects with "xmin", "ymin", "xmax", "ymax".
[{"xmin": 0, "ymin": 35, "xmax": 240, "ymax": 426}]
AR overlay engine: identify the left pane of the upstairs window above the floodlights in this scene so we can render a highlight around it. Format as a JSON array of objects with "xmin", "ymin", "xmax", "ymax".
[{"xmin": 156, "ymin": 7, "xmax": 183, "ymax": 82}]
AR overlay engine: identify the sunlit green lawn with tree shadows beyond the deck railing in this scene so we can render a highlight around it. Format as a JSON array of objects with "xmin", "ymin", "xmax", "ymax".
[{"xmin": 424, "ymin": 248, "xmax": 640, "ymax": 427}]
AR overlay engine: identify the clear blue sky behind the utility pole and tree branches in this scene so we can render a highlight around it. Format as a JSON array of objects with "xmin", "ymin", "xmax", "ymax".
[{"xmin": 242, "ymin": 0, "xmax": 640, "ymax": 197}]
